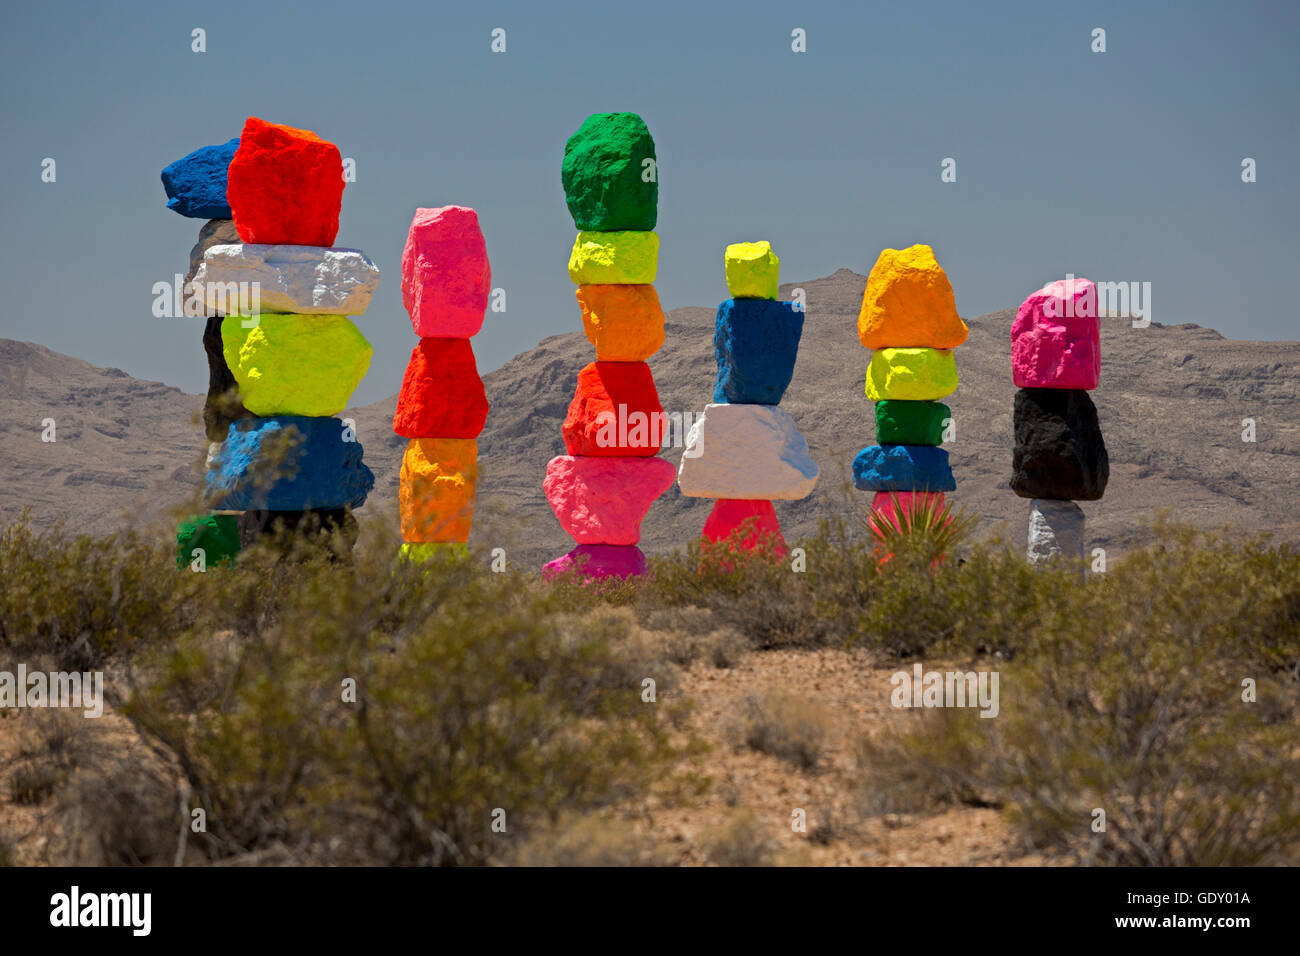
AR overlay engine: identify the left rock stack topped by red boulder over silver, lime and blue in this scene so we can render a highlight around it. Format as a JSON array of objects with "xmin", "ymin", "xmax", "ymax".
[{"xmin": 195, "ymin": 117, "xmax": 380, "ymax": 546}]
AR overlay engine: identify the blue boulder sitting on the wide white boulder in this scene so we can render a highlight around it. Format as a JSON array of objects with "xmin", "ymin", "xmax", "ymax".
[{"xmin": 714, "ymin": 299, "xmax": 803, "ymax": 405}]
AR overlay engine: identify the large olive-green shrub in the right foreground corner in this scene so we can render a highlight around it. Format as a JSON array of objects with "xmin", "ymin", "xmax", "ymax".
[{"xmin": 861, "ymin": 528, "xmax": 1300, "ymax": 866}]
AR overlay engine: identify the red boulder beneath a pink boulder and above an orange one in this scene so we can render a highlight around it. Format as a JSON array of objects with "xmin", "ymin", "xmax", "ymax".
[{"xmin": 393, "ymin": 338, "xmax": 488, "ymax": 438}]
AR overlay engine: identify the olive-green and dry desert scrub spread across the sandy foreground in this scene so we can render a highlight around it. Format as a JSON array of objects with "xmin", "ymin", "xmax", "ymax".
[{"xmin": 0, "ymin": 515, "xmax": 1300, "ymax": 865}]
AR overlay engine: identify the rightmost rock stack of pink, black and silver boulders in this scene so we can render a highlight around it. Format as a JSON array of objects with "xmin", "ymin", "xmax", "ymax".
[{"xmin": 1011, "ymin": 278, "xmax": 1110, "ymax": 563}]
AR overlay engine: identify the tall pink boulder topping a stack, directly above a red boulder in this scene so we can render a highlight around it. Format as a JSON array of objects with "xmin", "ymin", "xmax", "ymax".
[{"xmin": 402, "ymin": 206, "xmax": 491, "ymax": 338}]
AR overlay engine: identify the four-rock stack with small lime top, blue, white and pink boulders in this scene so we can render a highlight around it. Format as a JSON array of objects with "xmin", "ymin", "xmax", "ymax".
[{"xmin": 677, "ymin": 242, "xmax": 818, "ymax": 554}]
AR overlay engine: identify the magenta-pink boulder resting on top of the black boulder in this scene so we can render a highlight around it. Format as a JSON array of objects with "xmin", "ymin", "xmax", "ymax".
[{"xmin": 1011, "ymin": 278, "xmax": 1101, "ymax": 390}]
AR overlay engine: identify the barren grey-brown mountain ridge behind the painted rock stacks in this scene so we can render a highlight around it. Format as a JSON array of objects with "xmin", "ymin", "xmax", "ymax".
[{"xmin": 0, "ymin": 269, "xmax": 1300, "ymax": 564}]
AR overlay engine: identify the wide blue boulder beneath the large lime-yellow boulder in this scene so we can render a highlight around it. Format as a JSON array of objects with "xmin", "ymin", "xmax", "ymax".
[{"xmin": 204, "ymin": 415, "xmax": 374, "ymax": 511}]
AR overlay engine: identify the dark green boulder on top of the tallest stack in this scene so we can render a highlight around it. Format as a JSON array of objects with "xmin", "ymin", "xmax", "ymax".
[{"xmin": 560, "ymin": 113, "xmax": 659, "ymax": 233}]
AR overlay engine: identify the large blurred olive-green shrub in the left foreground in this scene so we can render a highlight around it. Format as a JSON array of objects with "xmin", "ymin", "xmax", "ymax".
[{"xmin": 125, "ymin": 530, "xmax": 691, "ymax": 864}]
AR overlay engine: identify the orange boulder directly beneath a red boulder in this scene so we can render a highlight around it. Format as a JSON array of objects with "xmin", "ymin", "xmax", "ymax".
[{"xmin": 398, "ymin": 438, "xmax": 478, "ymax": 544}]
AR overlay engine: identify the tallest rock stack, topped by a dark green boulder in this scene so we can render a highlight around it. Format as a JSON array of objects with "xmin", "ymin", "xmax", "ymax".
[{"xmin": 542, "ymin": 113, "xmax": 675, "ymax": 578}]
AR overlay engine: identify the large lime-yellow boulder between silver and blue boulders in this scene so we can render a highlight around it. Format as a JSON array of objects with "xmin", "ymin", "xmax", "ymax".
[{"xmin": 221, "ymin": 312, "xmax": 373, "ymax": 418}]
